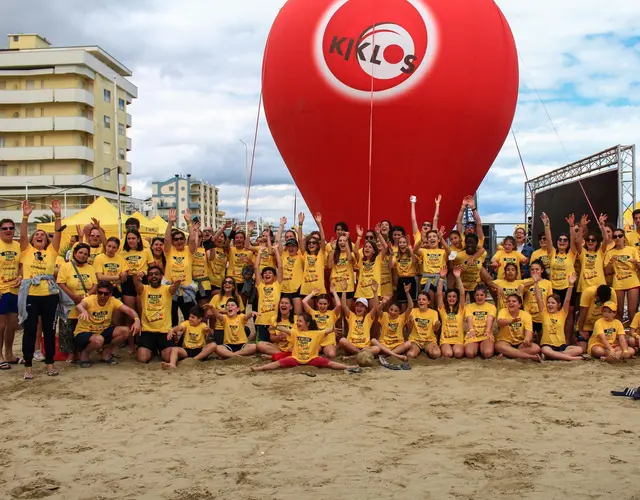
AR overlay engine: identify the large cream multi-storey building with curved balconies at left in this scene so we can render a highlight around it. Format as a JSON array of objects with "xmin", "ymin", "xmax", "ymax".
[{"xmin": 0, "ymin": 34, "xmax": 138, "ymax": 220}]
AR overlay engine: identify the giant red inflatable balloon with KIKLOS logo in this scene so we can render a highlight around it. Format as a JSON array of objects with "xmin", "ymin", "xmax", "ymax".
[{"xmin": 262, "ymin": 0, "xmax": 518, "ymax": 230}]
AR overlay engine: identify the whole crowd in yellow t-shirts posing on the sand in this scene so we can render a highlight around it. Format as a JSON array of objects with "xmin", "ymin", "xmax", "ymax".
[{"xmin": 0, "ymin": 196, "xmax": 640, "ymax": 380}]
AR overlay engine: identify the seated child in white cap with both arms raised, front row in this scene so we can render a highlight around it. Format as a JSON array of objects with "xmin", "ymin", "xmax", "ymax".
[{"xmin": 338, "ymin": 281, "xmax": 380, "ymax": 357}]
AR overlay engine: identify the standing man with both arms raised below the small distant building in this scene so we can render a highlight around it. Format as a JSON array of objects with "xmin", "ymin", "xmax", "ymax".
[{"xmin": 164, "ymin": 208, "xmax": 198, "ymax": 326}]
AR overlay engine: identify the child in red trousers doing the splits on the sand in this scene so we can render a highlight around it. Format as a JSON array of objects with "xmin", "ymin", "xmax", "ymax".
[{"xmin": 250, "ymin": 311, "xmax": 352, "ymax": 372}]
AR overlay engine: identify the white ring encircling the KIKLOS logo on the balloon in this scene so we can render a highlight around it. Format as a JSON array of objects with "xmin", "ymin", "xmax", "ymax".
[{"xmin": 312, "ymin": 0, "xmax": 439, "ymax": 101}]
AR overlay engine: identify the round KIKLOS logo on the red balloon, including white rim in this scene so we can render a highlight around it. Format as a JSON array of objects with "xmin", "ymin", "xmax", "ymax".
[{"xmin": 315, "ymin": 0, "xmax": 437, "ymax": 99}]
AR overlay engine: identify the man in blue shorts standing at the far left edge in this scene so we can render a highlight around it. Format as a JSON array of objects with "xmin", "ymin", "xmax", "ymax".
[{"xmin": 0, "ymin": 219, "xmax": 22, "ymax": 370}]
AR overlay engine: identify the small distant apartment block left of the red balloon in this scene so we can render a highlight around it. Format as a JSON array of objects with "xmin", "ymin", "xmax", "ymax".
[{"xmin": 151, "ymin": 174, "xmax": 218, "ymax": 229}]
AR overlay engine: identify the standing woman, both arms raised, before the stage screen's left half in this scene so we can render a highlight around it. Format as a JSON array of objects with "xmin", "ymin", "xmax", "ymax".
[{"xmin": 540, "ymin": 212, "xmax": 582, "ymax": 345}]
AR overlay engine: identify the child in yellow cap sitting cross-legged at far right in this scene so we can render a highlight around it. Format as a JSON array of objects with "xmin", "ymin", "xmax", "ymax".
[{"xmin": 587, "ymin": 302, "xmax": 636, "ymax": 361}]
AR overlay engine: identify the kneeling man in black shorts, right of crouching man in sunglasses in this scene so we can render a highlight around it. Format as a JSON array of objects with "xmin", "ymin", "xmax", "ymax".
[{"xmin": 133, "ymin": 264, "xmax": 181, "ymax": 363}]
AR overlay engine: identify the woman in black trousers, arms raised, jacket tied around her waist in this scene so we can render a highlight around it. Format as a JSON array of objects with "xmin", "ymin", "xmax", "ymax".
[{"xmin": 18, "ymin": 200, "xmax": 62, "ymax": 380}]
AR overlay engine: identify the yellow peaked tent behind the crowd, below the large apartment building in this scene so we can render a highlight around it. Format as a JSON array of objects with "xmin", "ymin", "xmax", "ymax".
[{"xmin": 38, "ymin": 196, "xmax": 158, "ymax": 237}]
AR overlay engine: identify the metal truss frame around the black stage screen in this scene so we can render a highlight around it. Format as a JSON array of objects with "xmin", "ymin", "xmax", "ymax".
[{"xmin": 524, "ymin": 145, "xmax": 636, "ymax": 242}]
